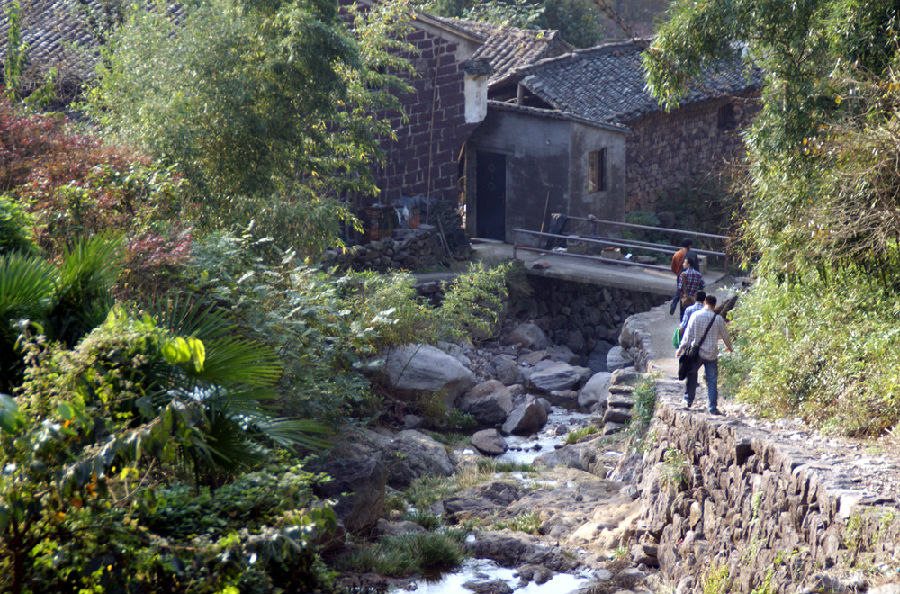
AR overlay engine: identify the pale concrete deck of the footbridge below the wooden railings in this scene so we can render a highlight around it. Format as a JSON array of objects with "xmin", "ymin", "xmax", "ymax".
[{"xmin": 472, "ymin": 240, "xmax": 723, "ymax": 295}]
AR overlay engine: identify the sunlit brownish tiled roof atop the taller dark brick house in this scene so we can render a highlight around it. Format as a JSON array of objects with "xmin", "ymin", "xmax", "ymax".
[{"xmin": 424, "ymin": 17, "xmax": 572, "ymax": 86}]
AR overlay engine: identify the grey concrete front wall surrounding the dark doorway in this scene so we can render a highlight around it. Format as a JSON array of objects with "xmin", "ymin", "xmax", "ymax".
[{"xmin": 466, "ymin": 109, "xmax": 570, "ymax": 241}]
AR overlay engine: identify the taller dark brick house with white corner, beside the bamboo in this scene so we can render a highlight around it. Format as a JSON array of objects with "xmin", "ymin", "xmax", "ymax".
[{"xmin": 375, "ymin": 12, "xmax": 572, "ymax": 205}]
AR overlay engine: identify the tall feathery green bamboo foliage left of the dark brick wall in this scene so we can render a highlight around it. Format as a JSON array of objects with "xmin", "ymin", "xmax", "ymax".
[{"xmin": 86, "ymin": 0, "xmax": 409, "ymax": 252}]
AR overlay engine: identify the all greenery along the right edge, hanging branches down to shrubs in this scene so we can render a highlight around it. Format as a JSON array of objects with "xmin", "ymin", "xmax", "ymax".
[{"xmin": 644, "ymin": 0, "xmax": 900, "ymax": 435}]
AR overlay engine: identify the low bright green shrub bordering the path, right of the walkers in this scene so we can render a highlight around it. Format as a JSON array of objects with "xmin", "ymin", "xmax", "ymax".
[{"xmin": 722, "ymin": 267, "xmax": 900, "ymax": 435}]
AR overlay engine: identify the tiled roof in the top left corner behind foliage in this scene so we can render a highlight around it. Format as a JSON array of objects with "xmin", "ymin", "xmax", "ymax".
[{"xmin": 0, "ymin": 0, "xmax": 97, "ymax": 85}]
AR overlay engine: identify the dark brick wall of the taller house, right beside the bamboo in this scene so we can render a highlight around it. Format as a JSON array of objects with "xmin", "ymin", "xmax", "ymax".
[{"xmin": 374, "ymin": 29, "xmax": 477, "ymax": 204}]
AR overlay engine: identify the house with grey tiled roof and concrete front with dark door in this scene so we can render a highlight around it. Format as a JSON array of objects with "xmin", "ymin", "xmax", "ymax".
[{"xmin": 465, "ymin": 41, "xmax": 759, "ymax": 240}]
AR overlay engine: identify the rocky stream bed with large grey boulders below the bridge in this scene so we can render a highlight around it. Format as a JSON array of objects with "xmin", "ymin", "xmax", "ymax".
[{"xmin": 322, "ymin": 324, "xmax": 659, "ymax": 594}]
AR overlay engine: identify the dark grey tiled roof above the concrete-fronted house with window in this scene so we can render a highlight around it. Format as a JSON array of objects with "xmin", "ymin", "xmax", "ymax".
[{"xmin": 513, "ymin": 41, "xmax": 760, "ymax": 126}]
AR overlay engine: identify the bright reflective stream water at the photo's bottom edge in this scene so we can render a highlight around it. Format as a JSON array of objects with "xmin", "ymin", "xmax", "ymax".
[{"xmin": 390, "ymin": 559, "xmax": 591, "ymax": 594}]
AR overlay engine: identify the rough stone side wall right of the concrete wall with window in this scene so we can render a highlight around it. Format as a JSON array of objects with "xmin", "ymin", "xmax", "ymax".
[{"xmin": 625, "ymin": 92, "xmax": 756, "ymax": 212}]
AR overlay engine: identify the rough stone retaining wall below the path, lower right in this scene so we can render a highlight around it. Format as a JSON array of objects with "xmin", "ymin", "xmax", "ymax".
[{"xmin": 638, "ymin": 398, "xmax": 900, "ymax": 594}]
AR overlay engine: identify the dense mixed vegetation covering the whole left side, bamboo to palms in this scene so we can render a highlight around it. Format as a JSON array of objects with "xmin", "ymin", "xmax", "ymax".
[{"xmin": 0, "ymin": 0, "xmax": 507, "ymax": 594}]
